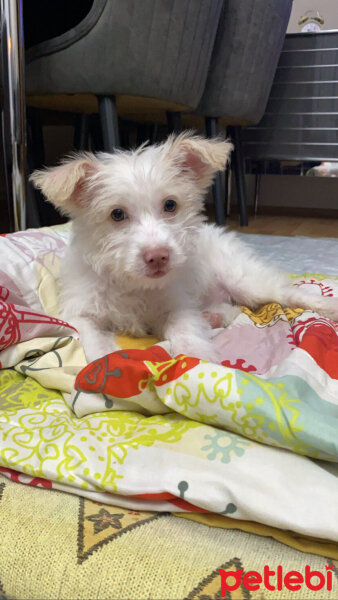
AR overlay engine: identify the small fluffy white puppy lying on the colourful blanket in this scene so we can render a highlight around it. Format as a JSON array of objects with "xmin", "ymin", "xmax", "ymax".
[{"xmin": 31, "ymin": 132, "xmax": 338, "ymax": 362}]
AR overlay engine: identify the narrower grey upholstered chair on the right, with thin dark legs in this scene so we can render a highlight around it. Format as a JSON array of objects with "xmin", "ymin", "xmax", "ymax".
[{"xmin": 196, "ymin": 0, "xmax": 292, "ymax": 225}]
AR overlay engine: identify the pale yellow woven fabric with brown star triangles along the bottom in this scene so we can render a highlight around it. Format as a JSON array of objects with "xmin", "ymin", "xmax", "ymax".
[{"xmin": 0, "ymin": 475, "xmax": 338, "ymax": 600}]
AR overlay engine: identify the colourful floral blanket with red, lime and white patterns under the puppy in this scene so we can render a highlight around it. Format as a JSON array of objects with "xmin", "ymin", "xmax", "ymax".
[{"xmin": 0, "ymin": 226, "xmax": 338, "ymax": 541}]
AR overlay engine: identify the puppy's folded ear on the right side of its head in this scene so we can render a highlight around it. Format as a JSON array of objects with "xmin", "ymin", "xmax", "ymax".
[{"xmin": 164, "ymin": 131, "xmax": 233, "ymax": 189}]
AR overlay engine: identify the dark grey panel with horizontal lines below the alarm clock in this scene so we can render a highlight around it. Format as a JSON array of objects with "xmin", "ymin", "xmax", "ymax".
[{"xmin": 243, "ymin": 31, "xmax": 338, "ymax": 161}]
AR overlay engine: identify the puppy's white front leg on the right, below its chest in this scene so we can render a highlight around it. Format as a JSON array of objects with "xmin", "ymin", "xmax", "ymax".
[{"xmin": 162, "ymin": 308, "xmax": 219, "ymax": 362}]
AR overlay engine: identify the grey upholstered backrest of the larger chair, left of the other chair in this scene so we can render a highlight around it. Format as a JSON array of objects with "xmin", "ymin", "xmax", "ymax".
[{"xmin": 26, "ymin": 0, "xmax": 223, "ymax": 108}]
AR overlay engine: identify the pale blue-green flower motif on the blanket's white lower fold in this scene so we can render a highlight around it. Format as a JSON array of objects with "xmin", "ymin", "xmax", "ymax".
[{"xmin": 201, "ymin": 431, "xmax": 252, "ymax": 464}]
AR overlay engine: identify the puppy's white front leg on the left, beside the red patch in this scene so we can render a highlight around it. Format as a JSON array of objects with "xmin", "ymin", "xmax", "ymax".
[{"xmin": 68, "ymin": 316, "xmax": 119, "ymax": 362}]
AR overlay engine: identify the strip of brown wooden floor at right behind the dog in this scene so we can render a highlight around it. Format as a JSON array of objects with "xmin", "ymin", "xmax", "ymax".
[{"xmin": 226, "ymin": 215, "xmax": 338, "ymax": 238}]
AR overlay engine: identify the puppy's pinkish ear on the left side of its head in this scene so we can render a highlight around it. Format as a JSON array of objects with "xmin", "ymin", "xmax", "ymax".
[{"xmin": 29, "ymin": 152, "xmax": 99, "ymax": 216}]
